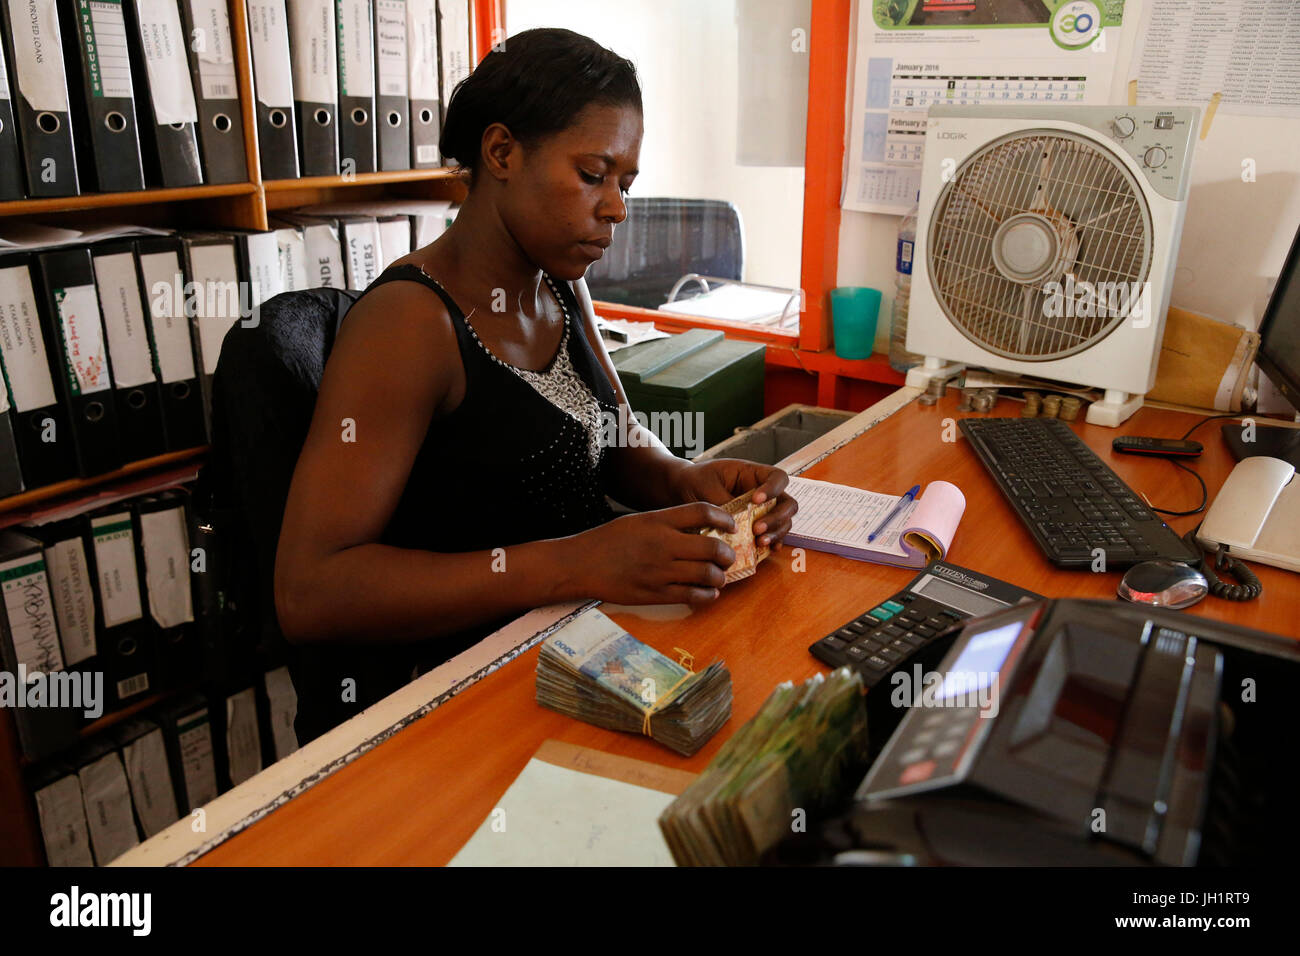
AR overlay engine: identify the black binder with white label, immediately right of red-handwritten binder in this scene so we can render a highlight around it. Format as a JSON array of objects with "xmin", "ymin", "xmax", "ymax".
[{"xmin": 91, "ymin": 242, "xmax": 166, "ymax": 462}]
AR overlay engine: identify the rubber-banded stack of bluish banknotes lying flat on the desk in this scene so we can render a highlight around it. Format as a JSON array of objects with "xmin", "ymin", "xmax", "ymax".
[{"xmin": 537, "ymin": 610, "xmax": 732, "ymax": 756}]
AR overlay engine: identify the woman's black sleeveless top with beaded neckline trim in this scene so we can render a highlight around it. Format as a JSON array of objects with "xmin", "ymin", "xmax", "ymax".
[{"xmin": 291, "ymin": 265, "xmax": 618, "ymax": 744}]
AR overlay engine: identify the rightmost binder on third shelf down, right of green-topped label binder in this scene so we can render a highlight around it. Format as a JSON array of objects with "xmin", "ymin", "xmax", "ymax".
[{"xmin": 131, "ymin": 492, "xmax": 200, "ymax": 688}]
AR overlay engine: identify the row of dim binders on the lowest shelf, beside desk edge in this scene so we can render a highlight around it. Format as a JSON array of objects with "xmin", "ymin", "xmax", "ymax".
[{"xmin": 26, "ymin": 667, "xmax": 298, "ymax": 866}]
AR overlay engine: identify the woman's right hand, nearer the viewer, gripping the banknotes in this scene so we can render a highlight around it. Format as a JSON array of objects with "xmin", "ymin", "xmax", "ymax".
[{"xmin": 577, "ymin": 501, "xmax": 736, "ymax": 606}]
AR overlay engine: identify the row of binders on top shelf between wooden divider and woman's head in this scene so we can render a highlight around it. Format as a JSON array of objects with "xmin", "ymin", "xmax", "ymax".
[{"xmin": 247, "ymin": 0, "xmax": 471, "ymax": 179}]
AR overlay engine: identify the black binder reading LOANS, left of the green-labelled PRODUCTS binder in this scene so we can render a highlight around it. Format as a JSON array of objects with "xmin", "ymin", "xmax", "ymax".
[{"xmin": 0, "ymin": 0, "xmax": 81, "ymax": 199}]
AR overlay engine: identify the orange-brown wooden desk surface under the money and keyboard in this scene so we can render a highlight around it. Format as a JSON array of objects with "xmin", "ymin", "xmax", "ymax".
[{"xmin": 196, "ymin": 393, "xmax": 1300, "ymax": 865}]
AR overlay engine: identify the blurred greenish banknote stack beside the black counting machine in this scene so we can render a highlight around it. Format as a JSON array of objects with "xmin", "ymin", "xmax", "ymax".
[{"xmin": 659, "ymin": 667, "xmax": 867, "ymax": 866}]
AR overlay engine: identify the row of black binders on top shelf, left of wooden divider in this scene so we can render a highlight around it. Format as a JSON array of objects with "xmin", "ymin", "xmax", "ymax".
[{"xmin": 0, "ymin": 0, "xmax": 248, "ymax": 200}]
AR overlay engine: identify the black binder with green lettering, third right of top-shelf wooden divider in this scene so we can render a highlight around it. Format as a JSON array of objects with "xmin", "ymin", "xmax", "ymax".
[{"xmin": 337, "ymin": 0, "xmax": 376, "ymax": 176}]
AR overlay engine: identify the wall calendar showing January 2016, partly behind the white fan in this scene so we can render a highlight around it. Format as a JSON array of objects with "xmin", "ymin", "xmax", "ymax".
[{"xmin": 841, "ymin": 0, "xmax": 1125, "ymax": 213}]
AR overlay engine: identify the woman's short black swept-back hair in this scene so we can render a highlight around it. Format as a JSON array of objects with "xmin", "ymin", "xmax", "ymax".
[{"xmin": 438, "ymin": 27, "xmax": 641, "ymax": 181}]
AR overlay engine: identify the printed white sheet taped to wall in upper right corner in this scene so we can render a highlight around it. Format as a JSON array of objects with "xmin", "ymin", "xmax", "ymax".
[{"xmin": 1132, "ymin": 0, "xmax": 1300, "ymax": 121}]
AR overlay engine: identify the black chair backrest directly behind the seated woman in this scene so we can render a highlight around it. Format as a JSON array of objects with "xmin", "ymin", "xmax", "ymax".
[{"xmin": 209, "ymin": 289, "xmax": 360, "ymax": 653}]
